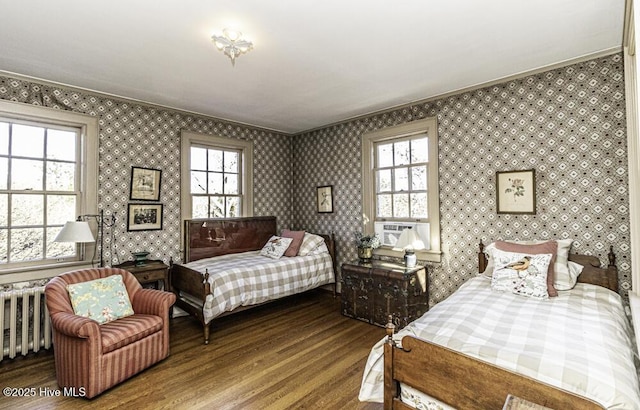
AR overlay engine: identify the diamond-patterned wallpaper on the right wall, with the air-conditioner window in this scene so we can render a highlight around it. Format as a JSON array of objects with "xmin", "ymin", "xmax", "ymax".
[{"xmin": 293, "ymin": 54, "xmax": 631, "ymax": 304}]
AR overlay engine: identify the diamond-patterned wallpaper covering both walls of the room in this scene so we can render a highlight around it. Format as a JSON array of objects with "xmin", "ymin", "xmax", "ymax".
[{"xmin": 0, "ymin": 54, "xmax": 631, "ymax": 304}]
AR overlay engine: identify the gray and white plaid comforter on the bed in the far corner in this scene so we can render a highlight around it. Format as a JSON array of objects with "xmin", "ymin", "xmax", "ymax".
[{"xmin": 185, "ymin": 251, "xmax": 334, "ymax": 323}]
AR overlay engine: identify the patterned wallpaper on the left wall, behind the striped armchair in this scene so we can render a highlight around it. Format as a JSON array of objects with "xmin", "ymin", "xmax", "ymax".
[{"xmin": 0, "ymin": 76, "xmax": 292, "ymax": 270}]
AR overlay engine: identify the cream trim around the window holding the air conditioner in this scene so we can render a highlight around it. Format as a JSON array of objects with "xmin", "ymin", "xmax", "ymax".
[{"xmin": 362, "ymin": 117, "xmax": 442, "ymax": 262}]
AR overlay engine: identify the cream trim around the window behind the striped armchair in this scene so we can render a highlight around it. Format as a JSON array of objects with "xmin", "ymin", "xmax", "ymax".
[{"xmin": 0, "ymin": 100, "xmax": 99, "ymax": 276}]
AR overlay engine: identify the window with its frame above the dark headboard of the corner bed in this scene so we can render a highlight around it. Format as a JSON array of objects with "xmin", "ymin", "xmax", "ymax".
[{"xmin": 181, "ymin": 131, "xmax": 253, "ymax": 219}]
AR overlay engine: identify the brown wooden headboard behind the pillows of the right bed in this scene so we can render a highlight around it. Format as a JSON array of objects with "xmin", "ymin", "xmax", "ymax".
[{"xmin": 478, "ymin": 241, "xmax": 618, "ymax": 293}]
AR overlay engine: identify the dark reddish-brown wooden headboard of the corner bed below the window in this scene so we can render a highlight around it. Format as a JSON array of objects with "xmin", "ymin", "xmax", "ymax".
[{"xmin": 184, "ymin": 216, "xmax": 277, "ymax": 262}]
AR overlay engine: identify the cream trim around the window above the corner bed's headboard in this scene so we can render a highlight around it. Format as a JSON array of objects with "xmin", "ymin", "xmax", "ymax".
[{"xmin": 180, "ymin": 130, "xmax": 253, "ymax": 225}]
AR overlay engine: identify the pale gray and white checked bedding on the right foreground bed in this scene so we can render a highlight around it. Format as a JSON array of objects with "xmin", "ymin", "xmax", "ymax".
[{"xmin": 359, "ymin": 276, "xmax": 640, "ymax": 409}]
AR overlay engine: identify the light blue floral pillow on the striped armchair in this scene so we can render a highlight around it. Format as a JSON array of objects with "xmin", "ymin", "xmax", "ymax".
[{"xmin": 67, "ymin": 275, "xmax": 133, "ymax": 324}]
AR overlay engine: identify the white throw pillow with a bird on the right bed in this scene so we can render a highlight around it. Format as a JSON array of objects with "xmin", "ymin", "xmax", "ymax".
[{"xmin": 491, "ymin": 249, "xmax": 553, "ymax": 299}]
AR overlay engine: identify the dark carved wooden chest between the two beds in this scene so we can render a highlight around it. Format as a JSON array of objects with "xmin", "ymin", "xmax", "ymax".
[{"xmin": 341, "ymin": 260, "xmax": 429, "ymax": 329}]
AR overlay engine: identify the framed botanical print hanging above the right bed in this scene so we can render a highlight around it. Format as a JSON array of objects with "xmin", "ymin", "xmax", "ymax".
[{"xmin": 496, "ymin": 169, "xmax": 536, "ymax": 215}]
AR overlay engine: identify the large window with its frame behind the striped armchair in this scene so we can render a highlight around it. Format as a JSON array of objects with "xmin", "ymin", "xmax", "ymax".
[{"xmin": 0, "ymin": 101, "xmax": 98, "ymax": 271}]
